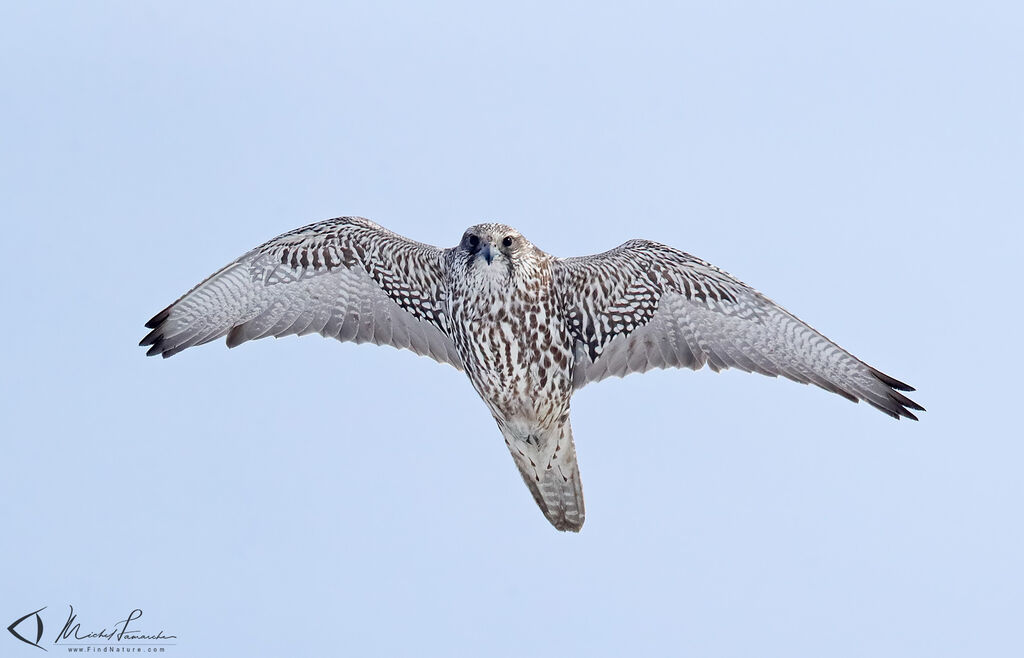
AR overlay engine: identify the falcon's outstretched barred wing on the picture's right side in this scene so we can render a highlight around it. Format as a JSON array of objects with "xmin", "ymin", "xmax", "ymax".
[{"xmin": 554, "ymin": 240, "xmax": 924, "ymax": 420}]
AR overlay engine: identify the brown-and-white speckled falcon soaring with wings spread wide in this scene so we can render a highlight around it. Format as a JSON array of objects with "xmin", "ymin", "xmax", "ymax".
[{"xmin": 140, "ymin": 217, "xmax": 924, "ymax": 532}]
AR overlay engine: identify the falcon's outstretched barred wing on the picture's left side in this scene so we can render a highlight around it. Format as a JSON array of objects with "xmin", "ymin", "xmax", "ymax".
[{"xmin": 140, "ymin": 217, "xmax": 462, "ymax": 369}]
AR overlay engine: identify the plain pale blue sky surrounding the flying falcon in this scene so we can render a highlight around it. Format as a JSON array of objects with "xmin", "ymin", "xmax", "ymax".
[{"xmin": 0, "ymin": 1, "xmax": 1024, "ymax": 657}]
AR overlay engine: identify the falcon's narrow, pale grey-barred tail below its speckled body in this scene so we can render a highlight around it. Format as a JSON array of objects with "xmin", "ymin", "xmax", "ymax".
[{"xmin": 502, "ymin": 420, "xmax": 584, "ymax": 532}]
